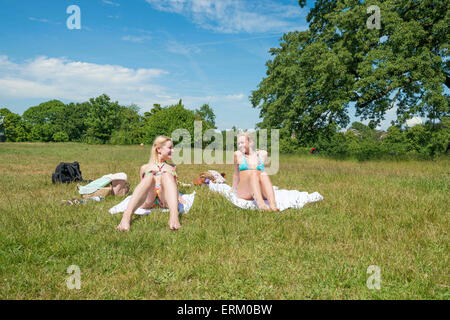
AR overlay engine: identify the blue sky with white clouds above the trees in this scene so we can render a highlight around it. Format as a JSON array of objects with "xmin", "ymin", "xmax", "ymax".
[{"xmin": 0, "ymin": 0, "xmax": 404, "ymax": 129}]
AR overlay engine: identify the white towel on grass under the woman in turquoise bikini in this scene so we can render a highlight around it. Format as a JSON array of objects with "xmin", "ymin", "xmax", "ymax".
[{"xmin": 209, "ymin": 182, "xmax": 323, "ymax": 211}]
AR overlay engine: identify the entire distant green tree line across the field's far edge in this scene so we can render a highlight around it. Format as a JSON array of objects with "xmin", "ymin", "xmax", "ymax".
[{"xmin": 0, "ymin": 94, "xmax": 450, "ymax": 160}]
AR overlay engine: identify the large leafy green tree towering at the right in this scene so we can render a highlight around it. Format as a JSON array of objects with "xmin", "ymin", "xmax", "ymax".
[{"xmin": 250, "ymin": 0, "xmax": 450, "ymax": 141}]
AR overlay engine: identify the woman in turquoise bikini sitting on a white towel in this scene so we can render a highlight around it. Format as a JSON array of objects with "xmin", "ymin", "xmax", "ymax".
[{"xmin": 233, "ymin": 132, "xmax": 279, "ymax": 211}]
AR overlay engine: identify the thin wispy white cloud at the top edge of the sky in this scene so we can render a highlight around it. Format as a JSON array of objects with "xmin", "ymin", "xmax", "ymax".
[{"xmin": 146, "ymin": 0, "xmax": 304, "ymax": 33}]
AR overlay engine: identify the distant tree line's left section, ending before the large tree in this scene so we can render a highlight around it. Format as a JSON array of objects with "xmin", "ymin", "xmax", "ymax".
[{"xmin": 0, "ymin": 94, "xmax": 216, "ymax": 144}]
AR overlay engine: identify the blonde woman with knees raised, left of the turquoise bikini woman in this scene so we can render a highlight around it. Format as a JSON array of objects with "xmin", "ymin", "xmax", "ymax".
[{"xmin": 117, "ymin": 136, "xmax": 181, "ymax": 231}]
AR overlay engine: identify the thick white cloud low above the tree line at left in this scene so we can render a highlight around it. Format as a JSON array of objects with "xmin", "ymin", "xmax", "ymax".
[{"xmin": 0, "ymin": 56, "xmax": 168, "ymax": 105}]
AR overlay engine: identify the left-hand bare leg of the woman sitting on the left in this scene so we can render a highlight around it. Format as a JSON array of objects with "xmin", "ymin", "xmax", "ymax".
[{"xmin": 117, "ymin": 175, "xmax": 155, "ymax": 231}]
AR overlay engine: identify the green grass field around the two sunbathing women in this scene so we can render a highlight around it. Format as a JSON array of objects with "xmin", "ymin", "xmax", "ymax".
[{"xmin": 0, "ymin": 143, "xmax": 450, "ymax": 300}]
